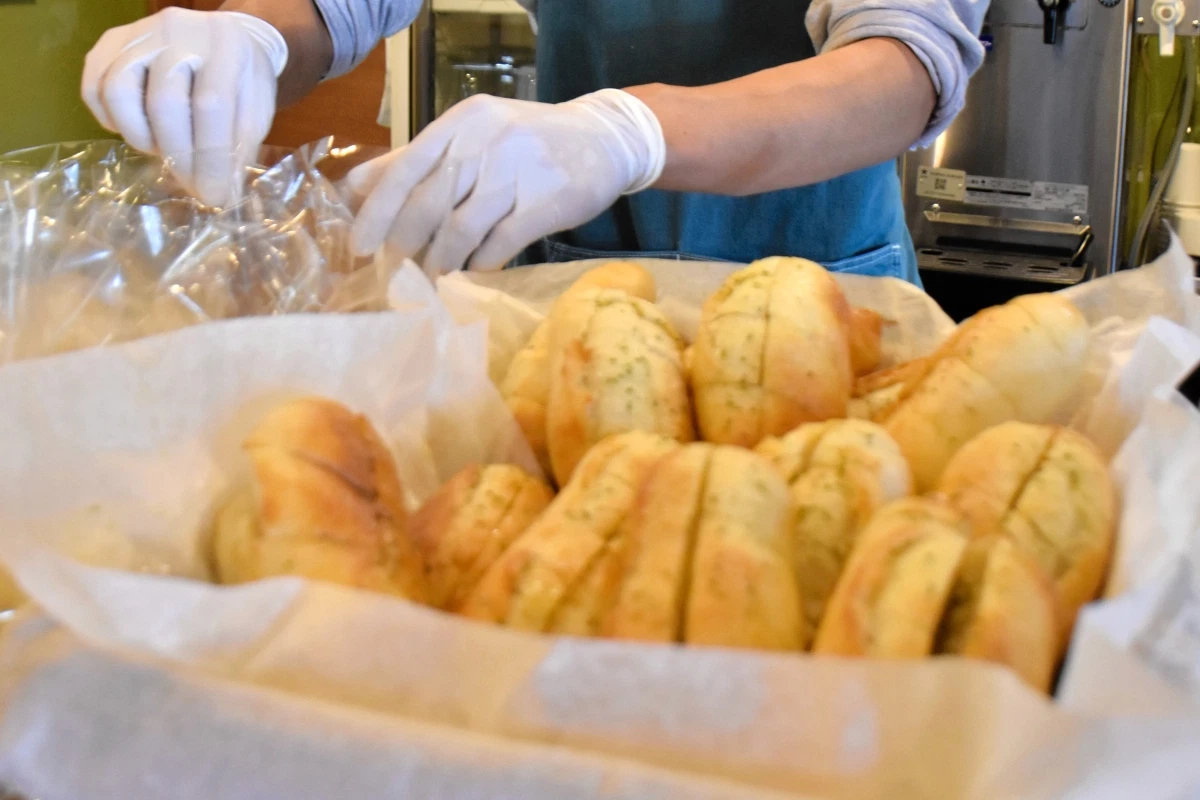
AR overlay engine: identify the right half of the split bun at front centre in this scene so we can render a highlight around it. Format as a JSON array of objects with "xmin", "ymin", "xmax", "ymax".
[{"xmin": 683, "ymin": 446, "xmax": 806, "ymax": 650}]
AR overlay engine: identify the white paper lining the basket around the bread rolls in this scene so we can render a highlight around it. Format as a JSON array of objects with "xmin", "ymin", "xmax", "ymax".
[{"xmin": 0, "ymin": 249, "xmax": 1200, "ymax": 800}]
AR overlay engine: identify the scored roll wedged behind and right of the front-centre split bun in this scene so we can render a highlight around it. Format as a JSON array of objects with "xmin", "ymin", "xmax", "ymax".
[{"xmin": 757, "ymin": 420, "xmax": 912, "ymax": 644}]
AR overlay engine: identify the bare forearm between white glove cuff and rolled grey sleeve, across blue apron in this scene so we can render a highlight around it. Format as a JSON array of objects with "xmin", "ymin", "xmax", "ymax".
[{"xmin": 626, "ymin": 38, "xmax": 937, "ymax": 194}]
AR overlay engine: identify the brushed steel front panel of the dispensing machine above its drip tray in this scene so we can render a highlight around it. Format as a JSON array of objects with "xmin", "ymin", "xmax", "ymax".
[{"xmin": 901, "ymin": 0, "xmax": 1129, "ymax": 273}]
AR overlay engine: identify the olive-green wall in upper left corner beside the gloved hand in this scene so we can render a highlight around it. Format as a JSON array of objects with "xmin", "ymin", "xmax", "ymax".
[{"xmin": 0, "ymin": 0, "xmax": 146, "ymax": 152}]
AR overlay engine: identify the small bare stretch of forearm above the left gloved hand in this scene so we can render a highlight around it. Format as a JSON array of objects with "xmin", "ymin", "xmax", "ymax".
[{"xmin": 221, "ymin": 0, "xmax": 334, "ymax": 108}]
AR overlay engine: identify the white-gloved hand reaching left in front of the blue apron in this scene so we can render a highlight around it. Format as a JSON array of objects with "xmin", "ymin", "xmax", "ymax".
[{"xmin": 347, "ymin": 89, "xmax": 666, "ymax": 273}]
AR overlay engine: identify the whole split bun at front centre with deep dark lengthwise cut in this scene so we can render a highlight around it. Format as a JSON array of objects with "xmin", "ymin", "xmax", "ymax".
[{"xmin": 604, "ymin": 444, "xmax": 804, "ymax": 650}]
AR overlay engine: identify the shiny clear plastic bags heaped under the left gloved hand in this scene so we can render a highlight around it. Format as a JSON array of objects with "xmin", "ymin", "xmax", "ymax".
[{"xmin": 0, "ymin": 138, "xmax": 389, "ymax": 363}]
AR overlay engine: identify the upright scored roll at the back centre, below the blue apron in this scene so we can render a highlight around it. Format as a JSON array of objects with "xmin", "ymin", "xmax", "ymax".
[{"xmin": 692, "ymin": 258, "xmax": 853, "ymax": 447}]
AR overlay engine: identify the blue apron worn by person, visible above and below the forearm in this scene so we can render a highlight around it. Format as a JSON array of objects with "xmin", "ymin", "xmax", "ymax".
[{"xmin": 523, "ymin": 0, "xmax": 920, "ymax": 285}]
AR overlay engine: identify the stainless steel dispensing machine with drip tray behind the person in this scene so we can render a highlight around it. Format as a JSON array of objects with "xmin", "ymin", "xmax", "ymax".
[{"xmin": 901, "ymin": 0, "xmax": 1200, "ymax": 318}]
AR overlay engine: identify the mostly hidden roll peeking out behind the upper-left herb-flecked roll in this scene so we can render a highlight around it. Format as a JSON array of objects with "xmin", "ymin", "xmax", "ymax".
[{"xmin": 500, "ymin": 261, "xmax": 658, "ymax": 475}]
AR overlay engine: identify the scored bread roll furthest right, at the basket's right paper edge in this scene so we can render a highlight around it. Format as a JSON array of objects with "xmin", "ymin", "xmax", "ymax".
[{"xmin": 938, "ymin": 422, "xmax": 1116, "ymax": 646}]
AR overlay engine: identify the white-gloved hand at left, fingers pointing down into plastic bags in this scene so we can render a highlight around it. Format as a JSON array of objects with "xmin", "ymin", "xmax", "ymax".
[{"xmin": 83, "ymin": 8, "xmax": 288, "ymax": 205}]
